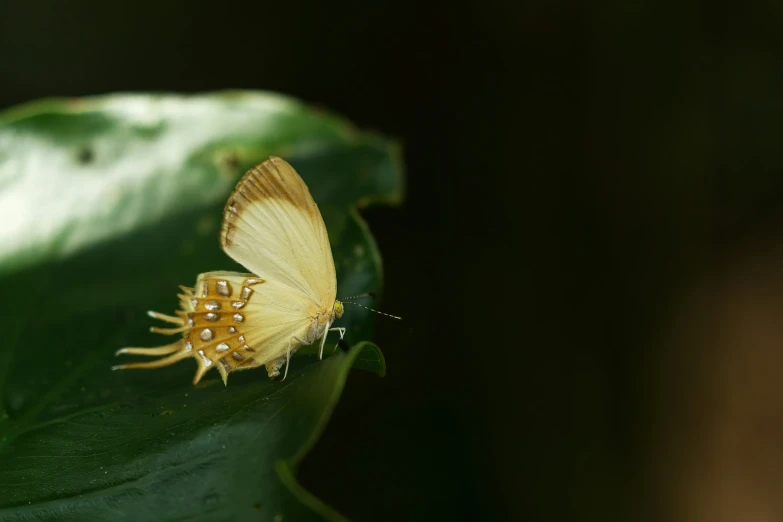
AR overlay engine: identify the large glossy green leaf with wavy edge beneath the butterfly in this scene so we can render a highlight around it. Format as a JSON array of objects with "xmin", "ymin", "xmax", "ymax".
[{"xmin": 0, "ymin": 92, "xmax": 402, "ymax": 521}]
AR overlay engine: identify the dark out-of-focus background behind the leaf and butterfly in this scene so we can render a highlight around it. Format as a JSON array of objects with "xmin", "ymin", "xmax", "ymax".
[{"xmin": 0, "ymin": 0, "xmax": 783, "ymax": 521}]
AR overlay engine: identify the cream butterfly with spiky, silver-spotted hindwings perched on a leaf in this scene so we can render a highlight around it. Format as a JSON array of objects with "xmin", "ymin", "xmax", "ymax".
[{"xmin": 112, "ymin": 156, "xmax": 345, "ymax": 385}]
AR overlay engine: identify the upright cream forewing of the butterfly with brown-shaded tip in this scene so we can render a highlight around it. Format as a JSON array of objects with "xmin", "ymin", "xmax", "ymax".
[{"xmin": 220, "ymin": 156, "xmax": 337, "ymax": 308}]
